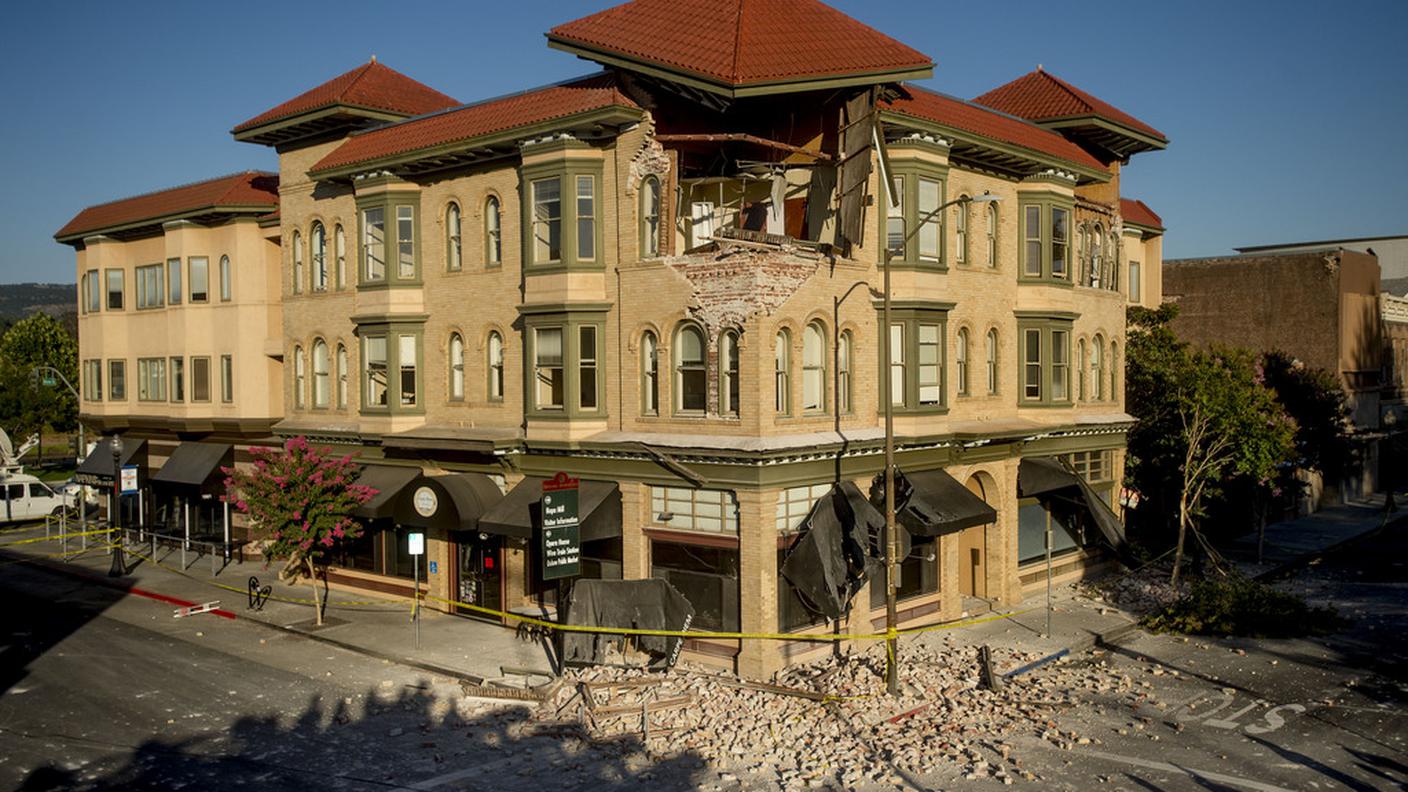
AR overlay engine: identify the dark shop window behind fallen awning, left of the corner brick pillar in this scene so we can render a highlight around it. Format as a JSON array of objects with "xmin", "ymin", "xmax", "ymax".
[{"xmin": 650, "ymin": 541, "xmax": 739, "ymax": 631}]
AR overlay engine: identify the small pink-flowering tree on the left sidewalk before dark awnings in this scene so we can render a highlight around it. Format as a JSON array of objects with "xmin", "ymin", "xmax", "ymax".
[{"xmin": 224, "ymin": 437, "xmax": 376, "ymax": 624}]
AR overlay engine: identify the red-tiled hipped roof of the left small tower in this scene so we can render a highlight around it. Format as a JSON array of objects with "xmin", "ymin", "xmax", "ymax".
[{"xmin": 231, "ymin": 61, "xmax": 459, "ymax": 134}]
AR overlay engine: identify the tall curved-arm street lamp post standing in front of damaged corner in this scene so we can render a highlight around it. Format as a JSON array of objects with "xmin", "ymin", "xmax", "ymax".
[{"xmin": 880, "ymin": 190, "xmax": 1002, "ymax": 696}]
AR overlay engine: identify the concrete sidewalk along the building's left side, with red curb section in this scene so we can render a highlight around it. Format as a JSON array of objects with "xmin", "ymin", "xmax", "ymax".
[{"xmin": 0, "ymin": 524, "xmax": 552, "ymax": 683}]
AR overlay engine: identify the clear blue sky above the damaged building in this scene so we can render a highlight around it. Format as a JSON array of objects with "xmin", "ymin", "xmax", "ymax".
[{"xmin": 0, "ymin": 0, "xmax": 1408, "ymax": 283}]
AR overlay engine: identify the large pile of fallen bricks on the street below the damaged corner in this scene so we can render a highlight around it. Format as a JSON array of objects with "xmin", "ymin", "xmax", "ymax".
[{"xmin": 523, "ymin": 644, "xmax": 1142, "ymax": 789}]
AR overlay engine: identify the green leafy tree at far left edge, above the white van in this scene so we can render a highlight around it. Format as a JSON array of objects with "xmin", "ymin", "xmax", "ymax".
[{"xmin": 0, "ymin": 313, "xmax": 79, "ymax": 455}]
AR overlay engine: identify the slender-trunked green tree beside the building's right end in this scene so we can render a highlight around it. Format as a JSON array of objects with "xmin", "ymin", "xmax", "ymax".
[{"xmin": 1126, "ymin": 304, "xmax": 1295, "ymax": 582}]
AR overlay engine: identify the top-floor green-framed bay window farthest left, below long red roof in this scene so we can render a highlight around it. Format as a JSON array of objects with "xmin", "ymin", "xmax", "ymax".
[{"xmin": 356, "ymin": 190, "xmax": 424, "ymax": 290}]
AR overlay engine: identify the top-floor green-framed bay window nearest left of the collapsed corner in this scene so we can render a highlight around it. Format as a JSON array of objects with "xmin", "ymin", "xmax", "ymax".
[{"xmin": 518, "ymin": 159, "xmax": 605, "ymax": 275}]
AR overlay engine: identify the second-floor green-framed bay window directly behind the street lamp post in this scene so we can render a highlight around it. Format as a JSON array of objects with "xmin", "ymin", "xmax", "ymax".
[{"xmin": 877, "ymin": 303, "xmax": 953, "ymax": 414}]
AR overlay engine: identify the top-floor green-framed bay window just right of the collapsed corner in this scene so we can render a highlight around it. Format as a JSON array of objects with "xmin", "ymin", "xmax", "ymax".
[{"xmin": 880, "ymin": 161, "xmax": 949, "ymax": 272}]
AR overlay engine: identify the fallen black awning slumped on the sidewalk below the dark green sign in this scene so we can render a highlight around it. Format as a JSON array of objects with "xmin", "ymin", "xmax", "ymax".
[{"xmin": 562, "ymin": 578, "xmax": 694, "ymax": 667}]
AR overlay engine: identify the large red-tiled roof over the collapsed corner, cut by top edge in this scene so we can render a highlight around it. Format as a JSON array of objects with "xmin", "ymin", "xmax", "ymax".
[{"xmin": 548, "ymin": 0, "xmax": 934, "ymax": 87}]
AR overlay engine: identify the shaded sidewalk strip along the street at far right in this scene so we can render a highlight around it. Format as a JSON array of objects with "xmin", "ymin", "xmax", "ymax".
[{"xmin": 1221, "ymin": 495, "xmax": 1408, "ymax": 578}]
